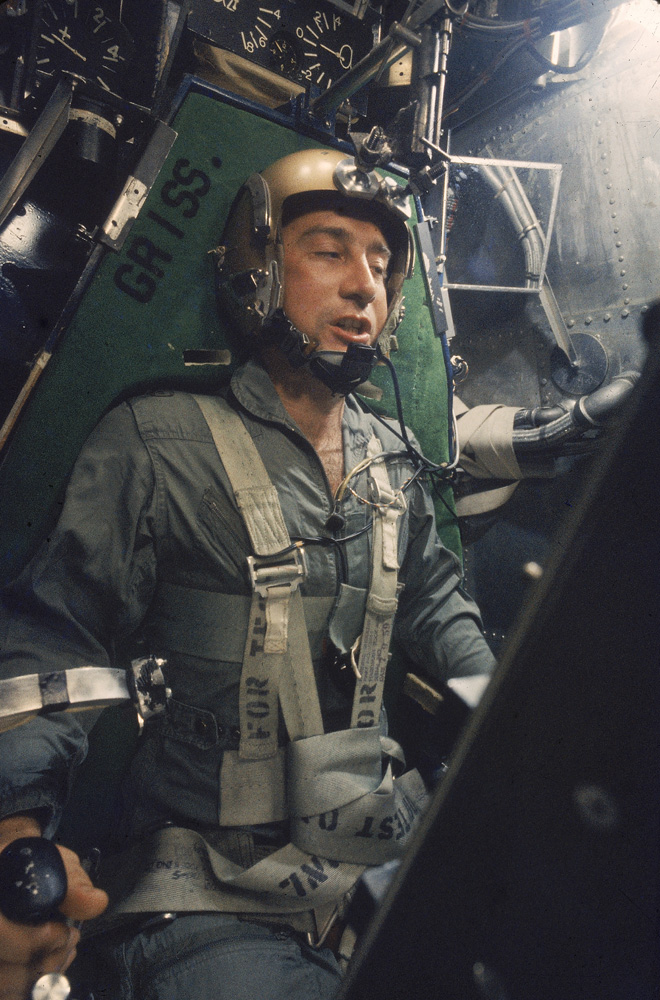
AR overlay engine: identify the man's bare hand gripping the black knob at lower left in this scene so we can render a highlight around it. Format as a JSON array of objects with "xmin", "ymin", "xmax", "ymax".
[{"xmin": 0, "ymin": 815, "xmax": 108, "ymax": 1000}]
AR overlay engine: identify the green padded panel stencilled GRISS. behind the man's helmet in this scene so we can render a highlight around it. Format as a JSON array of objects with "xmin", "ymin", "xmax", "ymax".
[{"xmin": 0, "ymin": 84, "xmax": 459, "ymax": 580}]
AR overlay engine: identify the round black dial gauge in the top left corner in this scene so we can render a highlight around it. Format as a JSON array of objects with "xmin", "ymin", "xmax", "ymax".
[{"xmin": 33, "ymin": 0, "xmax": 135, "ymax": 93}]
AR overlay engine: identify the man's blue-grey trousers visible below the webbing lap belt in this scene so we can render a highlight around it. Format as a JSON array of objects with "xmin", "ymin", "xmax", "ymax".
[{"xmin": 70, "ymin": 913, "xmax": 341, "ymax": 1000}]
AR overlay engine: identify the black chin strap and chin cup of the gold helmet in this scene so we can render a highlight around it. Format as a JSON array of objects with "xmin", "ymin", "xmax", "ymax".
[{"xmin": 268, "ymin": 309, "xmax": 380, "ymax": 396}]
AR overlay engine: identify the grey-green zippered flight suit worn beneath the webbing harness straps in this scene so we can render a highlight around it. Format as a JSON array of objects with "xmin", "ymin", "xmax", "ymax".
[{"xmin": 0, "ymin": 361, "xmax": 494, "ymax": 1000}]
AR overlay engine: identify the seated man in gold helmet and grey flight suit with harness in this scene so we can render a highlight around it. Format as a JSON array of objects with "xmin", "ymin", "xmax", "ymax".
[{"xmin": 0, "ymin": 150, "xmax": 493, "ymax": 1000}]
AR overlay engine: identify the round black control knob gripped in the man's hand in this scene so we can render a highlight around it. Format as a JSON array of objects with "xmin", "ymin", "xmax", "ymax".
[{"xmin": 0, "ymin": 837, "xmax": 67, "ymax": 924}]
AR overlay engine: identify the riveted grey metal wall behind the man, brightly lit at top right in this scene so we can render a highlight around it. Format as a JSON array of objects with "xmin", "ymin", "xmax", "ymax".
[{"xmin": 448, "ymin": 2, "xmax": 660, "ymax": 642}]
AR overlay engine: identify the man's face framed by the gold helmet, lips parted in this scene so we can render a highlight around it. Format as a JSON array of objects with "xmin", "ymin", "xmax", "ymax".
[{"xmin": 283, "ymin": 209, "xmax": 391, "ymax": 351}]
